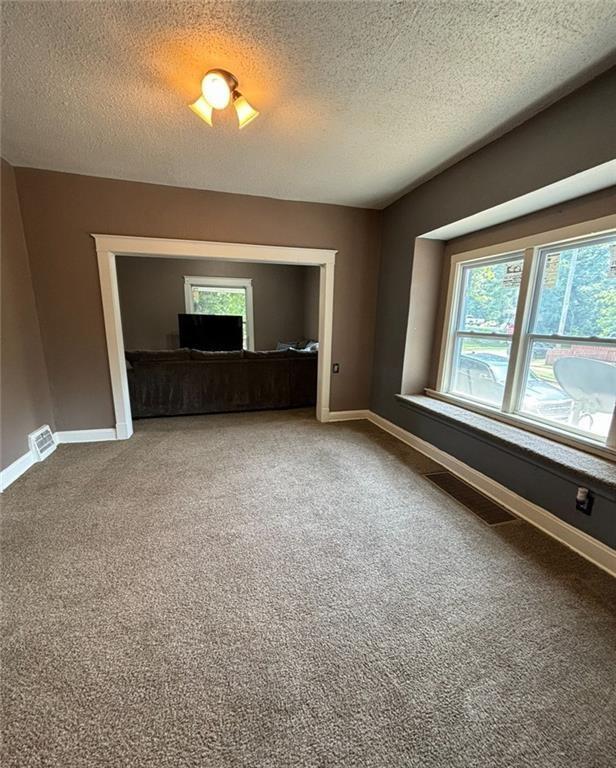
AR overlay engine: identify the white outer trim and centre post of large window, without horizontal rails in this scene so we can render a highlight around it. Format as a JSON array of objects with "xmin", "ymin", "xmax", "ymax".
[{"xmin": 434, "ymin": 214, "xmax": 616, "ymax": 461}]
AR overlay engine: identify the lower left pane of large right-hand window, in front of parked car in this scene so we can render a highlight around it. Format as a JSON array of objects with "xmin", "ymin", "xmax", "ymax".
[{"xmin": 451, "ymin": 338, "xmax": 510, "ymax": 406}]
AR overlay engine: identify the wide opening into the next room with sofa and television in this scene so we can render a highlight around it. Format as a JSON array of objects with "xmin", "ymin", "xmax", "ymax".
[{"xmin": 116, "ymin": 256, "xmax": 319, "ymax": 420}]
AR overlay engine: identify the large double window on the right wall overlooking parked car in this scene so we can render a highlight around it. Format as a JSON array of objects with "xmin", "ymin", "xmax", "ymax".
[{"xmin": 439, "ymin": 231, "xmax": 616, "ymax": 450}]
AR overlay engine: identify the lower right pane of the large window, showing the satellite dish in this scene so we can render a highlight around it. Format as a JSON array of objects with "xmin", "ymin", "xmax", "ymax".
[{"xmin": 520, "ymin": 341, "xmax": 616, "ymax": 439}]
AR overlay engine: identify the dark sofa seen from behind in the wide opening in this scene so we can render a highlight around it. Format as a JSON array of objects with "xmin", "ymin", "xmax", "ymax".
[{"xmin": 126, "ymin": 349, "xmax": 317, "ymax": 419}]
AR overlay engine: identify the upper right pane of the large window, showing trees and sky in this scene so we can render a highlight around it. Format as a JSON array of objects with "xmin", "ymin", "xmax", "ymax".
[{"xmin": 533, "ymin": 236, "xmax": 616, "ymax": 338}]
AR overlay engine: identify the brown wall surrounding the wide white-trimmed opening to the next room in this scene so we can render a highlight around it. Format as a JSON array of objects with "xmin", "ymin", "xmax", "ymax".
[{"xmin": 16, "ymin": 168, "xmax": 380, "ymax": 429}]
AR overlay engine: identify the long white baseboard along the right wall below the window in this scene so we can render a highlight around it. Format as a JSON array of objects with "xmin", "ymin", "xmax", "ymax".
[{"xmin": 368, "ymin": 411, "xmax": 616, "ymax": 576}]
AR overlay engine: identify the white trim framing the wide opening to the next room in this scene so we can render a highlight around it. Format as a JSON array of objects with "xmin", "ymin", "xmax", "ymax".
[{"xmin": 92, "ymin": 235, "xmax": 337, "ymax": 428}]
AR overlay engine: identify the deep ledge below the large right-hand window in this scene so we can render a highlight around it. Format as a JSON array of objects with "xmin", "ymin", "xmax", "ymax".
[{"xmin": 396, "ymin": 395, "xmax": 616, "ymax": 496}]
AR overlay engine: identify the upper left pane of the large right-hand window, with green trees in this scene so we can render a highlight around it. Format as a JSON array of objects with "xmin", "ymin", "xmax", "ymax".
[{"xmin": 458, "ymin": 256, "xmax": 524, "ymax": 334}]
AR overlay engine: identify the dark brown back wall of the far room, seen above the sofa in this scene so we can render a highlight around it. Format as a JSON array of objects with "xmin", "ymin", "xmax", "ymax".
[{"xmin": 116, "ymin": 256, "xmax": 319, "ymax": 349}]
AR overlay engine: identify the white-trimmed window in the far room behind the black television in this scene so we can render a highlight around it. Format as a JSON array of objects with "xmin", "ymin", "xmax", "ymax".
[{"xmin": 184, "ymin": 277, "xmax": 254, "ymax": 349}]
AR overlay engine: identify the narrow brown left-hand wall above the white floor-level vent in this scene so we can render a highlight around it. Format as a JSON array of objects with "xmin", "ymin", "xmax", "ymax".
[{"xmin": 0, "ymin": 160, "xmax": 54, "ymax": 469}]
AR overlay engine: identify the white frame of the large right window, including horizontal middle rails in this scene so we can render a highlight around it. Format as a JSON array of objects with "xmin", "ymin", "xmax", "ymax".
[{"xmin": 434, "ymin": 215, "xmax": 616, "ymax": 461}]
